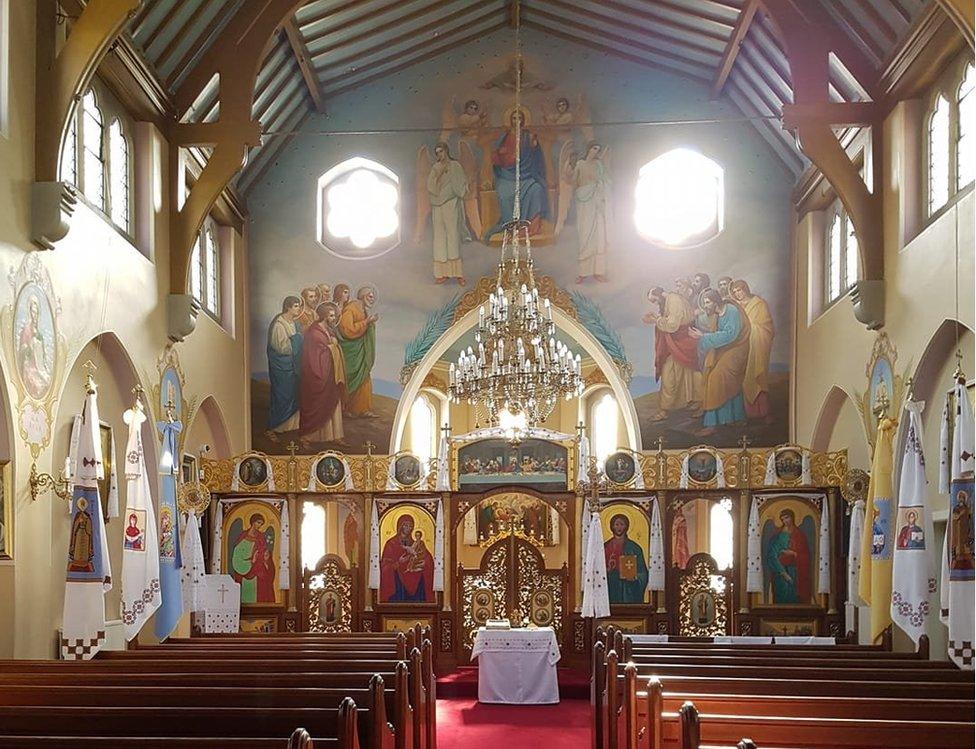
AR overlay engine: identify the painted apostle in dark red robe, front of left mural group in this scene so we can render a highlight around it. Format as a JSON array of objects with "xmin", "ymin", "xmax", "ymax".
[{"xmin": 298, "ymin": 302, "xmax": 346, "ymax": 446}]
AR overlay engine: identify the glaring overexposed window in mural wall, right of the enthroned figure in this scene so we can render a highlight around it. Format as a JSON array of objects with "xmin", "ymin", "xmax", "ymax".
[{"xmin": 634, "ymin": 148, "xmax": 725, "ymax": 248}]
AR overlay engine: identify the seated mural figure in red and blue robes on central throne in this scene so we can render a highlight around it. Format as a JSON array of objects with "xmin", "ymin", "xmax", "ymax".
[{"xmin": 484, "ymin": 110, "xmax": 549, "ymax": 242}]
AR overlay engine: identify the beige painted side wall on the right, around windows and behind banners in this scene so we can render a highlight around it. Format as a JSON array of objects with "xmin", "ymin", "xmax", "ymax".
[{"xmin": 793, "ymin": 76, "xmax": 976, "ymax": 658}]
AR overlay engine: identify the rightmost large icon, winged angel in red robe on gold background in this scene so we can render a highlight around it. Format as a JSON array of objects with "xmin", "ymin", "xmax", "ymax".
[{"xmin": 762, "ymin": 503, "xmax": 817, "ymax": 605}]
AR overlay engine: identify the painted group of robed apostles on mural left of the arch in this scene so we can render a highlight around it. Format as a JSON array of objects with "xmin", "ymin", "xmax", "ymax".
[{"xmin": 264, "ymin": 283, "xmax": 379, "ymax": 451}]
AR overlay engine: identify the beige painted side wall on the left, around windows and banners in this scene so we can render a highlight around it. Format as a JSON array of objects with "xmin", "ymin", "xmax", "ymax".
[{"xmin": 0, "ymin": 2, "xmax": 248, "ymax": 658}]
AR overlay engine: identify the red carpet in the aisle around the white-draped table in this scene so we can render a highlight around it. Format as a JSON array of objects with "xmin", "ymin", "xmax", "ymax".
[{"xmin": 437, "ymin": 667, "xmax": 590, "ymax": 749}]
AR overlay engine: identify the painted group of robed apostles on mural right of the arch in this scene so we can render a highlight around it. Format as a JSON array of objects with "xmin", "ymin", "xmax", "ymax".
[{"xmin": 642, "ymin": 273, "xmax": 775, "ymax": 437}]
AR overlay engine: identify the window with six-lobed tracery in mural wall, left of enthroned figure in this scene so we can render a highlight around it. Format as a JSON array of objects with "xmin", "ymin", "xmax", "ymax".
[{"xmin": 318, "ymin": 156, "xmax": 400, "ymax": 260}]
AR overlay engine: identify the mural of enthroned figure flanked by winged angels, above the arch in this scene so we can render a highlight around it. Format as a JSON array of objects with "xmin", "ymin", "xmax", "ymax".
[{"xmin": 414, "ymin": 79, "xmax": 611, "ymax": 286}]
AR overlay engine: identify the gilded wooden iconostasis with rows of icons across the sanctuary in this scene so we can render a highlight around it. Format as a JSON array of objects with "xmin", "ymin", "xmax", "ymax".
[{"xmin": 203, "ymin": 430, "xmax": 864, "ymax": 668}]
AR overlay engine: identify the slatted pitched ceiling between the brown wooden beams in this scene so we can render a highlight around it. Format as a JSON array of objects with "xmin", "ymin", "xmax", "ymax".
[{"xmin": 122, "ymin": 0, "xmax": 927, "ymax": 191}]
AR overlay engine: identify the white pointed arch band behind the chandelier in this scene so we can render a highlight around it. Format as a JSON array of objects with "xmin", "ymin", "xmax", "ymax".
[{"xmin": 390, "ymin": 300, "xmax": 641, "ymax": 453}]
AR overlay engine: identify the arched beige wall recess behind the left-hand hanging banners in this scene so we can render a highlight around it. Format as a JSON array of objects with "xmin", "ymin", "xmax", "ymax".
[{"xmin": 48, "ymin": 331, "xmax": 159, "ymax": 638}]
